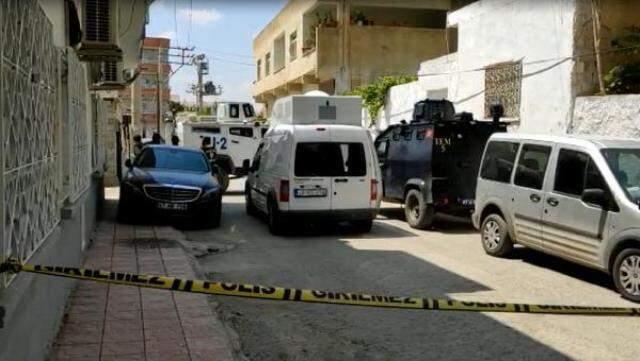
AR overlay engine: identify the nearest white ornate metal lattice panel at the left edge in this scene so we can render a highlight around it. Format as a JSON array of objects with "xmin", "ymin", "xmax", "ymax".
[{"xmin": 0, "ymin": 0, "xmax": 61, "ymax": 282}]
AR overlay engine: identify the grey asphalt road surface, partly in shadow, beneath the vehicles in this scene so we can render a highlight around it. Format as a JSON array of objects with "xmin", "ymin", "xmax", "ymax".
[{"xmin": 182, "ymin": 180, "xmax": 640, "ymax": 360}]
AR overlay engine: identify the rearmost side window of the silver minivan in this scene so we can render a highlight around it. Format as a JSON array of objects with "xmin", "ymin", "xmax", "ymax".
[{"xmin": 480, "ymin": 141, "xmax": 518, "ymax": 183}]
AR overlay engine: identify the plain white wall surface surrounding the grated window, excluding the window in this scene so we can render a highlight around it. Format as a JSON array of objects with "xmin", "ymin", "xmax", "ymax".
[{"xmin": 379, "ymin": 0, "xmax": 576, "ymax": 133}]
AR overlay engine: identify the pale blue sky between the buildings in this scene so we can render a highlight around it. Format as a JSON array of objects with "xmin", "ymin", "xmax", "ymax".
[{"xmin": 146, "ymin": 0, "xmax": 286, "ymax": 102}]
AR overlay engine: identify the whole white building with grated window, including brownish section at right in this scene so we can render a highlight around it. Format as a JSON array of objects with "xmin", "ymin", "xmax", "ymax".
[{"xmin": 378, "ymin": 0, "xmax": 640, "ymax": 133}]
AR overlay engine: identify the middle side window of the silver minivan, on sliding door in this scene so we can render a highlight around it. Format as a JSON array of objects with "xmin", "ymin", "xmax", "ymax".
[{"xmin": 513, "ymin": 144, "xmax": 551, "ymax": 189}]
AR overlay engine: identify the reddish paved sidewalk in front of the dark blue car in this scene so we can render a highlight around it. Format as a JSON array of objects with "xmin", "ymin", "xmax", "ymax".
[{"xmin": 50, "ymin": 195, "xmax": 233, "ymax": 361}]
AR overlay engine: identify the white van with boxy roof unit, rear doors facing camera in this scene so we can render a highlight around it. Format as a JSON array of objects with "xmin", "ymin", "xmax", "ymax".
[{"xmin": 245, "ymin": 96, "xmax": 382, "ymax": 234}]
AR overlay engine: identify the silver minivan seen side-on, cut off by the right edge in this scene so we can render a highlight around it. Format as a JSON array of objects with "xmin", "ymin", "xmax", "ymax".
[{"xmin": 473, "ymin": 134, "xmax": 640, "ymax": 302}]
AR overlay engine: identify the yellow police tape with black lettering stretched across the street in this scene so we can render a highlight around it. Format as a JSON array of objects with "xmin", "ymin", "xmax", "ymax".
[{"xmin": 0, "ymin": 260, "xmax": 640, "ymax": 316}]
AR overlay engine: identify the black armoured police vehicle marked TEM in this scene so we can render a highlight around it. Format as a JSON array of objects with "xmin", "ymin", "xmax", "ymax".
[{"xmin": 375, "ymin": 100, "xmax": 506, "ymax": 229}]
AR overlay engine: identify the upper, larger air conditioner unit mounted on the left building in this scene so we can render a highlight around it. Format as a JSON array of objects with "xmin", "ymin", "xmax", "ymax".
[{"xmin": 76, "ymin": 0, "xmax": 122, "ymax": 61}]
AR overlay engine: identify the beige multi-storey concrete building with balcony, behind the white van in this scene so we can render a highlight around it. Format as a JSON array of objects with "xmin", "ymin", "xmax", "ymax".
[{"xmin": 253, "ymin": 0, "xmax": 478, "ymax": 112}]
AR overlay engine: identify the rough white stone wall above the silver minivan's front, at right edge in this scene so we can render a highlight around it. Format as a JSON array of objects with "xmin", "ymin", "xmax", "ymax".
[{"xmin": 569, "ymin": 94, "xmax": 640, "ymax": 138}]
